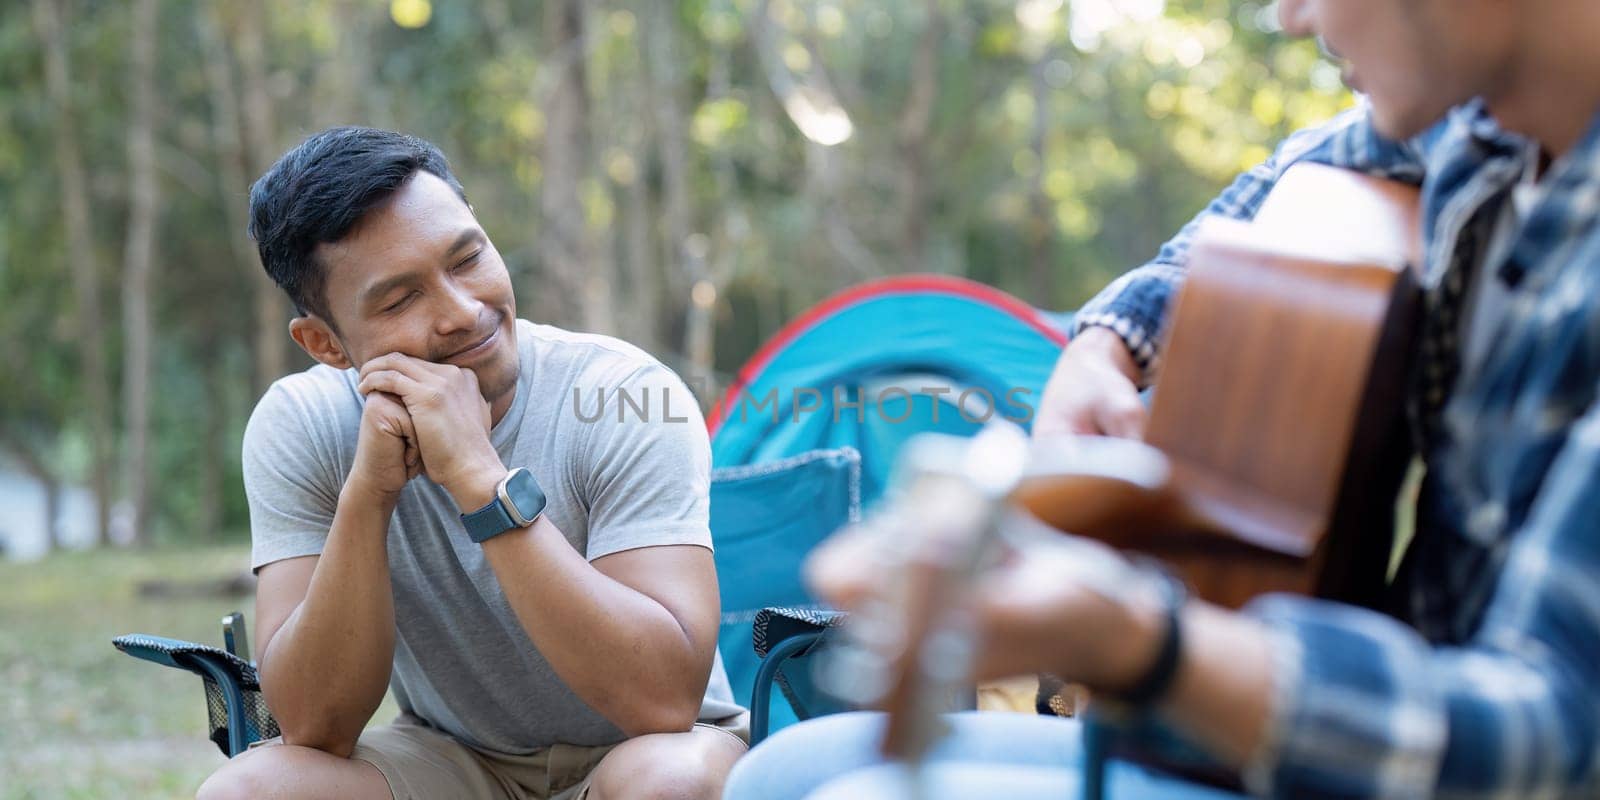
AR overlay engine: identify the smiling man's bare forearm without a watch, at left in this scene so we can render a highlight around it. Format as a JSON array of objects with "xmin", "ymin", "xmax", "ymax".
[{"xmin": 261, "ymin": 486, "xmax": 395, "ymax": 757}]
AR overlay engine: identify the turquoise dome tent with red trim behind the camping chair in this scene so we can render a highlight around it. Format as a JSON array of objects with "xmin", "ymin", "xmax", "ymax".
[{"xmin": 710, "ymin": 275, "xmax": 1070, "ymax": 504}]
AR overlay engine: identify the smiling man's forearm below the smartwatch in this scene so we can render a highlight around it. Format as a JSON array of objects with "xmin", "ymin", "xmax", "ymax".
[{"xmin": 470, "ymin": 518, "xmax": 710, "ymax": 736}]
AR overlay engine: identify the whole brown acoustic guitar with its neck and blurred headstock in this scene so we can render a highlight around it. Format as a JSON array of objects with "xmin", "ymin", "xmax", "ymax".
[{"xmin": 819, "ymin": 165, "xmax": 1421, "ymax": 774}]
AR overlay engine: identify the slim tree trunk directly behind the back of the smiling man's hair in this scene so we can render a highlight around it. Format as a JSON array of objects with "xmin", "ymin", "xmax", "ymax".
[{"xmin": 234, "ymin": 0, "xmax": 290, "ymax": 395}]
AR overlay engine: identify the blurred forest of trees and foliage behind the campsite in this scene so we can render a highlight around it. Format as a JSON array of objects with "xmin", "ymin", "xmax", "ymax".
[{"xmin": 0, "ymin": 0, "xmax": 1350, "ymax": 544}]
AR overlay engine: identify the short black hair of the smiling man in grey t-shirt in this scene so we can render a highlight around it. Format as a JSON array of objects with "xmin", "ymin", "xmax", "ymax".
[{"xmin": 250, "ymin": 126, "xmax": 467, "ymax": 325}]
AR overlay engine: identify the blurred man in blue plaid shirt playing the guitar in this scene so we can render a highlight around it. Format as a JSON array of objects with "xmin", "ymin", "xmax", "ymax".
[{"xmin": 728, "ymin": 0, "xmax": 1600, "ymax": 797}]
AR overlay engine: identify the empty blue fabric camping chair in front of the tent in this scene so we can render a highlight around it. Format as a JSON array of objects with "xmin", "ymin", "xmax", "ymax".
[{"xmin": 710, "ymin": 448, "xmax": 861, "ymax": 730}]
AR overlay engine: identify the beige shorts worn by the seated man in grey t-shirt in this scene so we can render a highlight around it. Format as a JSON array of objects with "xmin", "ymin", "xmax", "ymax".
[{"xmin": 251, "ymin": 714, "xmax": 750, "ymax": 800}]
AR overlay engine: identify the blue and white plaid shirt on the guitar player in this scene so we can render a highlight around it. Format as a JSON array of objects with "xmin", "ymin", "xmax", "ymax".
[{"xmin": 1077, "ymin": 102, "xmax": 1600, "ymax": 798}]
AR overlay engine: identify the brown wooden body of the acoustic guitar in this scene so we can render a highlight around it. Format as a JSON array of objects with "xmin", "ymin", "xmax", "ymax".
[{"xmin": 1013, "ymin": 165, "xmax": 1421, "ymax": 608}]
